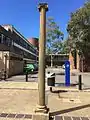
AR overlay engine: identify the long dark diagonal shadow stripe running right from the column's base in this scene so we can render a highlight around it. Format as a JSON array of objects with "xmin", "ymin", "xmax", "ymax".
[{"xmin": 50, "ymin": 104, "xmax": 90, "ymax": 116}]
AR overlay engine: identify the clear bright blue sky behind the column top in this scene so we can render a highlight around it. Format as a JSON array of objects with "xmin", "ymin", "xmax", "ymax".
[{"xmin": 0, "ymin": 0, "xmax": 86, "ymax": 39}]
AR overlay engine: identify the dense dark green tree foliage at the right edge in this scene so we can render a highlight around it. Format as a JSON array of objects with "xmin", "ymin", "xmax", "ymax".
[{"xmin": 67, "ymin": 2, "xmax": 90, "ymax": 56}]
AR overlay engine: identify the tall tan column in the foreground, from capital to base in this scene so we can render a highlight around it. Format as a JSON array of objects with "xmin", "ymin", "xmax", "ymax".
[{"xmin": 37, "ymin": 3, "xmax": 48, "ymax": 113}]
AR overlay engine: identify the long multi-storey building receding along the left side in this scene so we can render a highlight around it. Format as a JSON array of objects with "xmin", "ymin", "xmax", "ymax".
[{"xmin": 0, "ymin": 25, "xmax": 38, "ymax": 77}]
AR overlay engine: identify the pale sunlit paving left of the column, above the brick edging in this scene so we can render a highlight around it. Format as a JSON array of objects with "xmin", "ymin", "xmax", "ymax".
[{"xmin": 0, "ymin": 89, "xmax": 37, "ymax": 113}]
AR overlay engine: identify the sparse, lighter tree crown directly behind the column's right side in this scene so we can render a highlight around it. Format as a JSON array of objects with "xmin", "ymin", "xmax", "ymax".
[{"xmin": 46, "ymin": 17, "xmax": 64, "ymax": 54}]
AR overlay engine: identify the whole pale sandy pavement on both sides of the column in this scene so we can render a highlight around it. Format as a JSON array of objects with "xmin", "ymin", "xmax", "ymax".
[{"xmin": 0, "ymin": 82, "xmax": 90, "ymax": 120}]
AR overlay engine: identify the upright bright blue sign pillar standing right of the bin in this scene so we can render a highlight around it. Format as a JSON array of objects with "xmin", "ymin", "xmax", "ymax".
[{"xmin": 65, "ymin": 61, "xmax": 70, "ymax": 86}]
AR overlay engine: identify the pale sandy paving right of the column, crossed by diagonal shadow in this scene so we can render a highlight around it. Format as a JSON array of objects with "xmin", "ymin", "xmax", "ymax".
[{"xmin": 49, "ymin": 92, "xmax": 90, "ymax": 117}]
